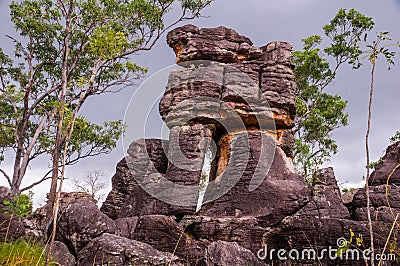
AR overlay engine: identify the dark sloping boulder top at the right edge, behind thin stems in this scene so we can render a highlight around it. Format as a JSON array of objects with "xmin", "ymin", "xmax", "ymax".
[{"xmin": 368, "ymin": 142, "xmax": 400, "ymax": 186}]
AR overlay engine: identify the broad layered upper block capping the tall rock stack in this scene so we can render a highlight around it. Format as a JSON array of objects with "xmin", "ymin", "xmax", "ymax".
[{"xmin": 160, "ymin": 25, "xmax": 296, "ymax": 136}]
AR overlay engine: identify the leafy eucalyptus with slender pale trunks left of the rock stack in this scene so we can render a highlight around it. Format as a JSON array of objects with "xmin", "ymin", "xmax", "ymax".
[{"xmin": 0, "ymin": 0, "xmax": 211, "ymax": 206}]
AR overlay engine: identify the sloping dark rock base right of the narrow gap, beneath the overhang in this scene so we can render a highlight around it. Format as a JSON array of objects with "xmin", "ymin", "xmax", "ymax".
[{"xmin": 201, "ymin": 135, "xmax": 309, "ymax": 226}]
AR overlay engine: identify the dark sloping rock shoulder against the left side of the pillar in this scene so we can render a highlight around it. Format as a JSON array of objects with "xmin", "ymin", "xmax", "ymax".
[{"xmin": 101, "ymin": 139, "xmax": 174, "ymax": 219}]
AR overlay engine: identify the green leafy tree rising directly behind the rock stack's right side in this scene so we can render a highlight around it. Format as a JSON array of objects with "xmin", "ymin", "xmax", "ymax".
[{"xmin": 293, "ymin": 9, "xmax": 374, "ymax": 179}]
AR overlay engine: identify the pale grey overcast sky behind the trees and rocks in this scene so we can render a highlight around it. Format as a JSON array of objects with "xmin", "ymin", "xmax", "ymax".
[{"xmin": 0, "ymin": 0, "xmax": 400, "ymax": 207}]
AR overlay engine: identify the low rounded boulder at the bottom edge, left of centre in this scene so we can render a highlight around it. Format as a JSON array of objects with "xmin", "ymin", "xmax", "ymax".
[{"xmin": 77, "ymin": 233, "xmax": 184, "ymax": 266}]
